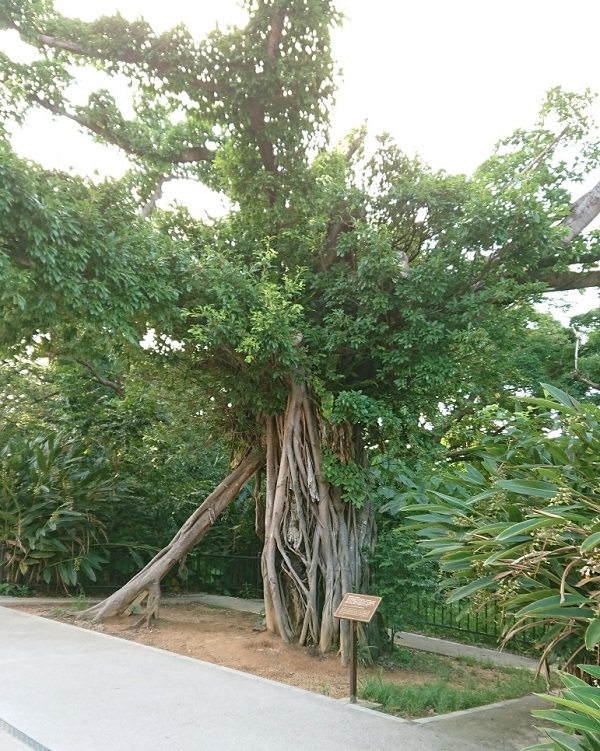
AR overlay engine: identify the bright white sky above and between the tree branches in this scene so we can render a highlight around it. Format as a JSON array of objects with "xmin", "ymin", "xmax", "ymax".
[{"xmin": 1, "ymin": 0, "xmax": 600, "ymax": 318}]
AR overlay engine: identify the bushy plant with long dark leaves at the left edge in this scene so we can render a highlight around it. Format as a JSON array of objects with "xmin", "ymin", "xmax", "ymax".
[{"xmin": 0, "ymin": 433, "xmax": 123, "ymax": 588}]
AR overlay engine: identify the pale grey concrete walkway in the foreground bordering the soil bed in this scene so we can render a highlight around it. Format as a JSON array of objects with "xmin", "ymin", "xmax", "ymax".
[{"xmin": 0, "ymin": 607, "xmax": 543, "ymax": 751}]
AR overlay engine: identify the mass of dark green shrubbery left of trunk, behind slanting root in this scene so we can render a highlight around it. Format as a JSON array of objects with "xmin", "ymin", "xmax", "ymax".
[{"xmin": 0, "ymin": 357, "xmax": 259, "ymax": 586}]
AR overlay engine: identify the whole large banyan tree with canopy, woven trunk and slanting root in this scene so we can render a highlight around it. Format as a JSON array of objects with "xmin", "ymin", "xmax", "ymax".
[{"xmin": 0, "ymin": 0, "xmax": 600, "ymax": 655}]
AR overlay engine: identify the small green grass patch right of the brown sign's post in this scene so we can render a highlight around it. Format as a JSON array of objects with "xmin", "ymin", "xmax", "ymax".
[{"xmin": 359, "ymin": 648, "xmax": 546, "ymax": 718}]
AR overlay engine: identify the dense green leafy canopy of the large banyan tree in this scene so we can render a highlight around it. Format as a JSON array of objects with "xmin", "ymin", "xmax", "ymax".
[{"xmin": 0, "ymin": 0, "xmax": 597, "ymax": 458}]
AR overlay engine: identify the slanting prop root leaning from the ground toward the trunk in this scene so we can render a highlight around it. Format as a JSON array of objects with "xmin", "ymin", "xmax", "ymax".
[{"xmin": 78, "ymin": 455, "xmax": 263, "ymax": 625}]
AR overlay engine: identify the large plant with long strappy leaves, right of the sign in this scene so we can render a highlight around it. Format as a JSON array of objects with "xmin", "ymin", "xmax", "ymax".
[{"xmin": 392, "ymin": 384, "xmax": 600, "ymax": 666}]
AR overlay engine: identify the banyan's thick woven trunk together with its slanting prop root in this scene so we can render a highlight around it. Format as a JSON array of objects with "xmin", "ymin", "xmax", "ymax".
[{"xmin": 78, "ymin": 382, "xmax": 375, "ymax": 665}]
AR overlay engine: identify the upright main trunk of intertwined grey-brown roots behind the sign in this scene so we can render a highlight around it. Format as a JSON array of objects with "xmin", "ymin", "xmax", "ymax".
[{"xmin": 262, "ymin": 383, "xmax": 375, "ymax": 665}]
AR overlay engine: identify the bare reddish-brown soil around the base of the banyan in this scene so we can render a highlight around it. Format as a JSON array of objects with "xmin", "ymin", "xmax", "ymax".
[{"xmin": 14, "ymin": 603, "xmax": 540, "ymax": 712}]
